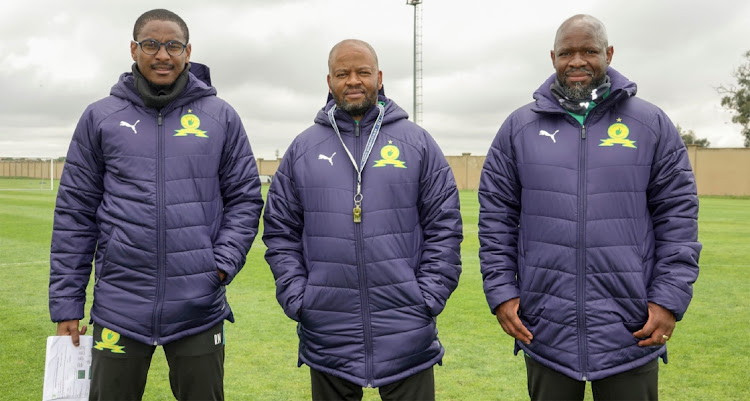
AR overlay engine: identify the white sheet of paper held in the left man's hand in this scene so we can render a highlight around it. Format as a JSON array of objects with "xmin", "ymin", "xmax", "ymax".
[{"xmin": 42, "ymin": 336, "xmax": 93, "ymax": 401}]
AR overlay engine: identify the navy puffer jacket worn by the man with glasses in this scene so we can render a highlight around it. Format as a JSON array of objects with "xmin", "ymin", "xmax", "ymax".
[{"xmin": 49, "ymin": 65, "xmax": 263, "ymax": 344}]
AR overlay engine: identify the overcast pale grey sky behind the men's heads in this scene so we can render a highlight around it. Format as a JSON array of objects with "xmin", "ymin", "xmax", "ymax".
[{"xmin": 0, "ymin": 0, "xmax": 750, "ymax": 159}]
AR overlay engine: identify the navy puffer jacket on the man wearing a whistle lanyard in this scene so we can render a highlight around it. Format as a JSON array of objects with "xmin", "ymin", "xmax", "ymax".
[{"xmin": 263, "ymin": 96, "xmax": 462, "ymax": 387}]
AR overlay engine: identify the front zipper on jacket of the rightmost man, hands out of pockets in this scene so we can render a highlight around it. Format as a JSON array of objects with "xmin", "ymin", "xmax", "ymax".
[{"xmin": 576, "ymin": 124, "xmax": 588, "ymax": 381}]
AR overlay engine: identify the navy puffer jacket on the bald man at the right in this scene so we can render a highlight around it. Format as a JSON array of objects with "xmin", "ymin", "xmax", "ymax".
[{"xmin": 479, "ymin": 68, "xmax": 701, "ymax": 380}]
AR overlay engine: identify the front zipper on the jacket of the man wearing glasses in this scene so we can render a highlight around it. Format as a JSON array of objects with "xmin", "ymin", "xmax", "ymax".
[{"xmin": 152, "ymin": 111, "xmax": 166, "ymax": 345}]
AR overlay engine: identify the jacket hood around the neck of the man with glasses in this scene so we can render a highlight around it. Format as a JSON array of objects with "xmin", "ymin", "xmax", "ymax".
[{"xmin": 109, "ymin": 63, "xmax": 216, "ymax": 111}]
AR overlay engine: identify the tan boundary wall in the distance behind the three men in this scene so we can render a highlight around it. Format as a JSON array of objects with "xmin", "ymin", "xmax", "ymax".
[{"xmin": 0, "ymin": 145, "xmax": 750, "ymax": 196}]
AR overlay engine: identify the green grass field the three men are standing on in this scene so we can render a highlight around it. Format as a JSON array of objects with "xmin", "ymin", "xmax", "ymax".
[{"xmin": 0, "ymin": 179, "xmax": 750, "ymax": 401}]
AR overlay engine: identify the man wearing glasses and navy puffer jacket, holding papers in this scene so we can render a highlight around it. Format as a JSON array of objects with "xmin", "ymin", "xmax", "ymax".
[{"xmin": 49, "ymin": 10, "xmax": 263, "ymax": 400}]
